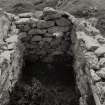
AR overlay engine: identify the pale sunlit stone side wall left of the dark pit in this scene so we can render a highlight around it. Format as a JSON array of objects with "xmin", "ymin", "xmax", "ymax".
[{"xmin": 0, "ymin": 13, "xmax": 22, "ymax": 105}]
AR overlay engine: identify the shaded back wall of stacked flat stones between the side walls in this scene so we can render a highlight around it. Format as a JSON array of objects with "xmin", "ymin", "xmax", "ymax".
[{"xmin": 15, "ymin": 8, "xmax": 73, "ymax": 63}]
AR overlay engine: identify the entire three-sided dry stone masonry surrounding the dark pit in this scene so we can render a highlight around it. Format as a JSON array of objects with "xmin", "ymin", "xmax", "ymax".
[{"xmin": 0, "ymin": 7, "xmax": 105, "ymax": 105}]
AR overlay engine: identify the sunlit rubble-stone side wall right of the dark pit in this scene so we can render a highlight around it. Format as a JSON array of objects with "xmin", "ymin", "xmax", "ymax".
[{"xmin": 75, "ymin": 18, "xmax": 105, "ymax": 105}]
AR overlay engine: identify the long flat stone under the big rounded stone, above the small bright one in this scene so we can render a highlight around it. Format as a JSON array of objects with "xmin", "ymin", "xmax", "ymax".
[{"xmin": 48, "ymin": 26, "xmax": 69, "ymax": 33}]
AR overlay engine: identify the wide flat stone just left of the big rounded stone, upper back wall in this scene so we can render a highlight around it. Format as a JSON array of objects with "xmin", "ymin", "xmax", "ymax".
[{"xmin": 37, "ymin": 20, "xmax": 55, "ymax": 29}]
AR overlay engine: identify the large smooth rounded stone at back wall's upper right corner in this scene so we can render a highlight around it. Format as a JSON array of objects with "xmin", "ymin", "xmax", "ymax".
[{"xmin": 56, "ymin": 17, "xmax": 71, "ymax": 26}]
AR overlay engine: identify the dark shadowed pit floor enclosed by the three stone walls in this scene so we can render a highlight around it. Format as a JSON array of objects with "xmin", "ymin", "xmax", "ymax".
[{"xmin": 9, "ymin": 55, "xmax": 79, "ymax": 105}]
